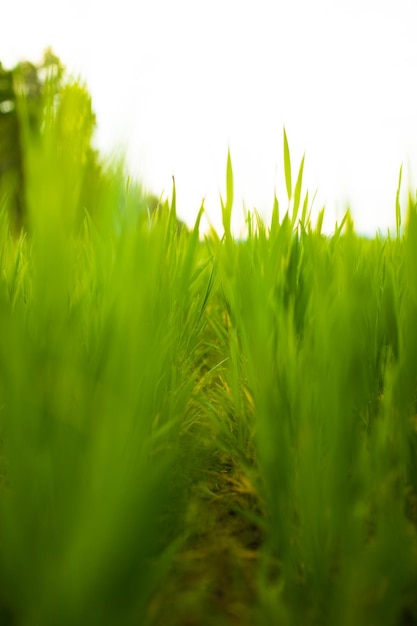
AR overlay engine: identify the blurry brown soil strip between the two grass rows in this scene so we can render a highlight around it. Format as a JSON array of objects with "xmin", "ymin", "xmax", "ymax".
[{"xmin": 149, "ymin": 450, "xmax": 262, "ymax": 626}]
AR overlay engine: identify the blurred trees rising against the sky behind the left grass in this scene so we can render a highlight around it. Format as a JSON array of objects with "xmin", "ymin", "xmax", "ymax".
[{"xmin": 0, "ymin": 49, "xmax": 172, "ymax": 231}]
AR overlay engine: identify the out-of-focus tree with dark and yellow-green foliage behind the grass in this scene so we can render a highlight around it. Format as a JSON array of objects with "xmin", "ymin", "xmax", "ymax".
[{"xmin": 0, "ymin": 49, "xmax": 184, "ymax": 232}]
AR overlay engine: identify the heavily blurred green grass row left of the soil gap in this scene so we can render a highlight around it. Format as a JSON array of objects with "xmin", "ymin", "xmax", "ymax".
[{"xmin": 0, "ymin": 90, "xmax": 205, "ymax": 625}]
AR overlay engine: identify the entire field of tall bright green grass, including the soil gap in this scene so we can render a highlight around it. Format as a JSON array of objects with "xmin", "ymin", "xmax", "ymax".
[{"xmin": 0, "ymin": 83, "xmax": 417, "ymax": 626}]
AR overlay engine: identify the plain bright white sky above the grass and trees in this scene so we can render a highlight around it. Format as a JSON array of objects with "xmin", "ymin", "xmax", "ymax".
[{"xmin": 0, "ymin": 0, "xmax": 417, "ymax": 234}]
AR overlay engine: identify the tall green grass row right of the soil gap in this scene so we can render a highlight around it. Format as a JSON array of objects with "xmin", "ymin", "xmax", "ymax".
[{"xmin": 210, "ymin": 139, "xmax": 417, "ymax": 625}]
